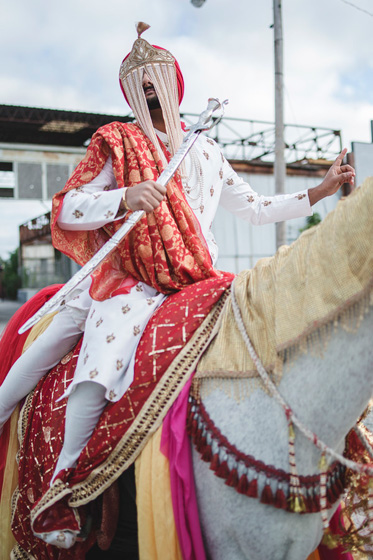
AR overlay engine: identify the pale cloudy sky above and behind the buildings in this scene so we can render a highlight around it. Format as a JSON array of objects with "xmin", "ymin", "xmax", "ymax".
[{"xmin": 0, "ymin": 0, "xmax": 373, "ymax": 256}]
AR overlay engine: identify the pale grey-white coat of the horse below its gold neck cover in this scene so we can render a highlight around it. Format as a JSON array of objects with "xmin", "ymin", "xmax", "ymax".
[{"xmin": 193, "ymin": 185, "xmax": 373, "ymax": 560}]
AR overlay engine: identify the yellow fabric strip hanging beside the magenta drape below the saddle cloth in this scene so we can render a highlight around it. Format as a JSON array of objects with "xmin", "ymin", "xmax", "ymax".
[{"xmin": 135, "ymin": 426, "xmax": 183, "ymax": 560}]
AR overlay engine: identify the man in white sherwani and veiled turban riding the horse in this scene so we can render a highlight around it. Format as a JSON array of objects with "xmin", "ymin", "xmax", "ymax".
[{"xmin": 0, "ymin": 24, "xmax": 355, "ymax": 548}]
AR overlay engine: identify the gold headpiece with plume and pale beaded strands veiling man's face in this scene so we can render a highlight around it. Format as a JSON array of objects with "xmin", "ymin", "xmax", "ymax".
[{"xmin": 119, "ymin": 22, "xmax": 183, "ymax": 166}]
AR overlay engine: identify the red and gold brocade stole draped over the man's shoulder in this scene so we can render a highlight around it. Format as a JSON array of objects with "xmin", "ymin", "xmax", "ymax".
[{"xmin": 51, "ymin": 122, "xmax": 220, "ymax": 300}]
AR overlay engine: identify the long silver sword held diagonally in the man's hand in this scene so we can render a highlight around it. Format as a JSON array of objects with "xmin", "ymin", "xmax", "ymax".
[{"xmin": 18, "ymin": 98, "xmax": 228, "ymax": 334}]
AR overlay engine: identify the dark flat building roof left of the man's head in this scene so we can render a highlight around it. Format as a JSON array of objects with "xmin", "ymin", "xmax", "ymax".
[{"xmin": 0, "ymin": 105, "xmax": 134, "ymax": 146}]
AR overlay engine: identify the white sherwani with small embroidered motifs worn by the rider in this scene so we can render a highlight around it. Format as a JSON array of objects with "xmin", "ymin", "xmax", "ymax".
[{"xmin": 58, "ymin": 132, "xmax": 312, "ymax": 401}]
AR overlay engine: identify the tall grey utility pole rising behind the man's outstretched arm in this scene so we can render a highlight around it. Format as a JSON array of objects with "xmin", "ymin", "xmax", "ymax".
[{"xmin": 273, "ymin": 0, "xmax": 286, "ymax": 249}]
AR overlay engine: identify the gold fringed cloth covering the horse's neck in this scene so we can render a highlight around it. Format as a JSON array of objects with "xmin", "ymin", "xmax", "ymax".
[{"xmin": 197, "ymin": 178, "xmax": 373, "ymax": 383}]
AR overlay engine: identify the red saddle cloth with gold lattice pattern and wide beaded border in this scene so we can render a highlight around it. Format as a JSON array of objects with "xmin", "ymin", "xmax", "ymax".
[{"xmin": 8, "ymin": 273, "xmax": 233, "ymax": 560}]
